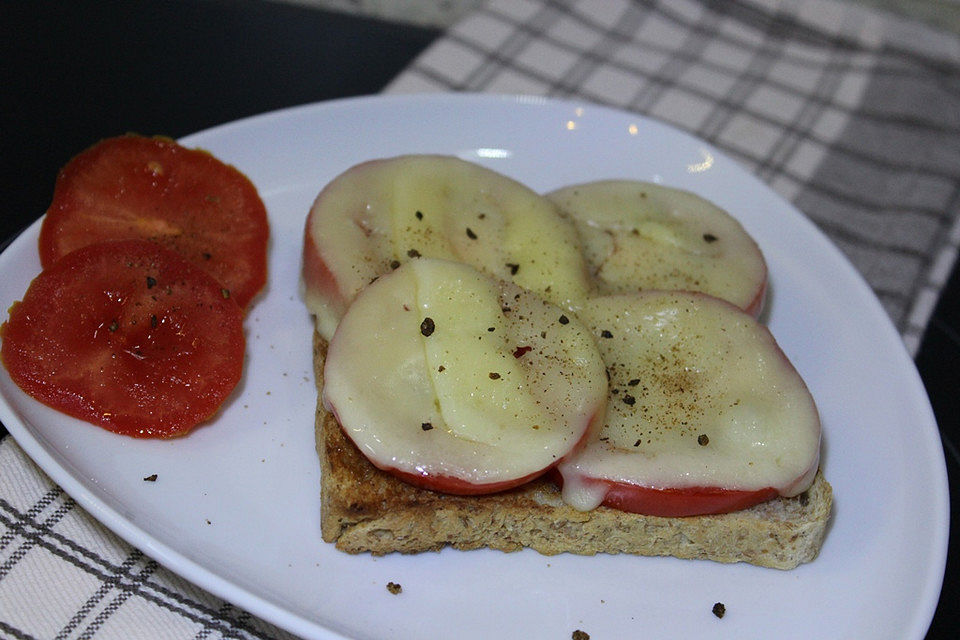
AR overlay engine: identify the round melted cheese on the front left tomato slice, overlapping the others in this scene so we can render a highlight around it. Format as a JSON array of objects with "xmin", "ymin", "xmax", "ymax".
[{"xmin": 323, "ymin": 259, "xmax": 607, "ymax": 484}]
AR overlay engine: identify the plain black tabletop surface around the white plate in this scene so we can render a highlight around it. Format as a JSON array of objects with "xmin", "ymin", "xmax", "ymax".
[{"xmin": 0, "ymin": 0, "xmax": 960, "ymax": 640}]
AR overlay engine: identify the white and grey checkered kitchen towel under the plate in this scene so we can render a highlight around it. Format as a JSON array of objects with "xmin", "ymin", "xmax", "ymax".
[{"xmin": 0, "ymin": 0, "xmax": 960, "ymax": 639}]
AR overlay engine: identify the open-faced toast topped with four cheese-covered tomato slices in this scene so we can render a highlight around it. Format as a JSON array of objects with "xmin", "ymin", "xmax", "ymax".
[{"xmin": 303, "ymin": 156, "xmax": 832, "ymax": 569}]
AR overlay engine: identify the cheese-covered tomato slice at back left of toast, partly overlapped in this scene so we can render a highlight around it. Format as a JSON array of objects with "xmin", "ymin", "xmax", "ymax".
[{"xmin": 304, "ymin": 155, "xmax": 589, "ymax": 339}]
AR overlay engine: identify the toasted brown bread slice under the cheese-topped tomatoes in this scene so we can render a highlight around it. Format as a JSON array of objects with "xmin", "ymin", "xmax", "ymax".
[{"xmin": 313, "ymin": 334, "xmax": 832, "ymax": 569}]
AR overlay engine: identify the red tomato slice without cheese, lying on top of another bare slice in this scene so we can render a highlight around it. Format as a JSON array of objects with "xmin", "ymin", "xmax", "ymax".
[{"xmin": 0, "ymin": 240, "xmax": 245, "ymax": 438}]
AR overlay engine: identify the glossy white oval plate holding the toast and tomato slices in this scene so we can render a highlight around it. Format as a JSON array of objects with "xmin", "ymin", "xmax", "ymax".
[{"xmin": 0, "ymin": 95, "xmax": 948, "ymax": 639}]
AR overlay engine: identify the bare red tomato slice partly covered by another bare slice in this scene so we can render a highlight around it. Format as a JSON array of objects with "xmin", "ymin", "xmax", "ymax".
[{"xmin": 39, "ymin": 135, "xmax": 269, "ymax": 308}]
